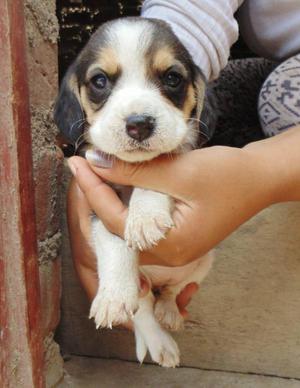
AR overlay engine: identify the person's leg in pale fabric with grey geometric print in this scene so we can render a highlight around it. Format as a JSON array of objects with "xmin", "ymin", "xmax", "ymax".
[{"xmin": 258, "ymin": 54, "xmax": 300, "ymax": 136}]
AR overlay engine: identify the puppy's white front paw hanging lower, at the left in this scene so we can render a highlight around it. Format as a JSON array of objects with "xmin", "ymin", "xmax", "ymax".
[{"xmin": 90, "ymin": 287, "xmax": 138, "ymax": 329}]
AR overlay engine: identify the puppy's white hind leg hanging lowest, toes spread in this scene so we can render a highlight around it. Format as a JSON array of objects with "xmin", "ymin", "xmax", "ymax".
[{"xmin": 133, "ymin": 291, "xmax": 179, "ymax": 368}]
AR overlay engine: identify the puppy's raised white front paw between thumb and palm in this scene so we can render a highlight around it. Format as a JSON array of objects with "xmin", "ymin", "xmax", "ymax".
[{"xmin": 125, "ymin": 204, "xmax": 173, "ymax": 251}]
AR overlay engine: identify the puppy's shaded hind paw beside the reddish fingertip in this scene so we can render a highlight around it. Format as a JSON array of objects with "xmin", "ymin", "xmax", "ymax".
[{"xmin": 154, "ymin": 299, "xmax": 184, "ymax": 331}]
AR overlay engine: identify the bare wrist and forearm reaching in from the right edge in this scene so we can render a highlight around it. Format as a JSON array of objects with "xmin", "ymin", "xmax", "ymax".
[{"xmin": 245, "ymin": 126, "xmax": 300, "ymax": 203}]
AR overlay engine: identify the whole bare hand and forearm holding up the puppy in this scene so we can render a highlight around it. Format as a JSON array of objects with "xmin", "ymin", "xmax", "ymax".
[{"xmin": 68, "ymin": 127, "xmax": 300, "ymax": 328}]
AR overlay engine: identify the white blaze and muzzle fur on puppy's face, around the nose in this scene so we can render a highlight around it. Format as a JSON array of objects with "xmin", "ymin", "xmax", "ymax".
[{"xmin": 89, "ymin": 20, "xmax": 195, "ymax": 162}]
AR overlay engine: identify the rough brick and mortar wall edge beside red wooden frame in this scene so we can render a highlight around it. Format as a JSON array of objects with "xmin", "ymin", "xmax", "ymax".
[{"xmin": 25, "ymin": 0, "xmax": 63, "ymax": 386}]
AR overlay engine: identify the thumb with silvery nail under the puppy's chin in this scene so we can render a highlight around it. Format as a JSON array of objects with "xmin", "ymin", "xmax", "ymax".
[{"xmin": 86, "ymin": 150, "xmax": 196, "ymax": 199}]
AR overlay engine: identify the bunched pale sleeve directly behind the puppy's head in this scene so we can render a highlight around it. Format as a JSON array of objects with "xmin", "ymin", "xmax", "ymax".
[{"xmin": 142, "ymin": 0, "xmax": 244, "ymax": 81}]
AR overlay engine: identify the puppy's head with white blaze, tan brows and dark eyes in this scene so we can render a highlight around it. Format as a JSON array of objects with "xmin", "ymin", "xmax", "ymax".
[{"xmin": 55, "ymin": 18, "xmax": 213, "ymax": 162}]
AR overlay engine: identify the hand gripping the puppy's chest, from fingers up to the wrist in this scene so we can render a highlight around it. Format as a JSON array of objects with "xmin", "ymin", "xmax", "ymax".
[{"xmin": 70, "ymin": 142, "xmax": 282, "ymax": 266}]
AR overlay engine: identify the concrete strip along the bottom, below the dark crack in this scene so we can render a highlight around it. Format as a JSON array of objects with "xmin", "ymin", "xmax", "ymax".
[{"xmin": 59, "ymin": 357, "xmax": 300, "ymax": 388}]
